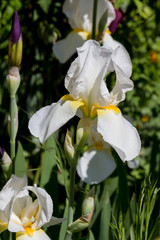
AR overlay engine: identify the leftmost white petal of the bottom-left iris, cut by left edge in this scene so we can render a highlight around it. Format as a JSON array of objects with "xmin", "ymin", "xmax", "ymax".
[{"xmin": 0, "ymin": 175, "xmax": 27, "ymax": 233}]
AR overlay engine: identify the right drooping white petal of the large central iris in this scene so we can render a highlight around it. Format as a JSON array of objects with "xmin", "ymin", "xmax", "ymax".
[{"xmin": 97, "ymin": 110, "xmax": 141, "ymax": 161}]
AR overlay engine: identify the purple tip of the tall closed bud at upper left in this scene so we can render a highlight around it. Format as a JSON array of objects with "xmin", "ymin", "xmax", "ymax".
[{"xmin": 10, "ymin": 11, "xmax": 21, "ymax": 44}]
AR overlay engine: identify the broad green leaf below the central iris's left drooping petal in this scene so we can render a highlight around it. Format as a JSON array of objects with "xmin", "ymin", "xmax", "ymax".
[{"xmin": 40, "ymin": 135, "xmax": 56, "ymax": 187}]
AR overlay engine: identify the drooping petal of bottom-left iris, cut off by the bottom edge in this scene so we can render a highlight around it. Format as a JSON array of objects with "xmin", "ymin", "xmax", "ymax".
[{"xmin": 16, "ymin": 229, "xmax": 51, "ymax": 240}]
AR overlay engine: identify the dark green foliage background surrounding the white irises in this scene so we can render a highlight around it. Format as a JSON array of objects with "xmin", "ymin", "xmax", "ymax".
[{"xmin": 0, "ymin": 0, "xmax": 160, "ymax": 240}]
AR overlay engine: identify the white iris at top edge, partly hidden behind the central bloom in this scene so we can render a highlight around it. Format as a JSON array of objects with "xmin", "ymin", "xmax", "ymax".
[{"xmin": 53, "ymin": 0, "xmax": 115, "ymax": 63}]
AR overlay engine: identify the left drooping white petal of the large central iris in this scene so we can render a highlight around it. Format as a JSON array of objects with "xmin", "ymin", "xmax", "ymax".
[{"xmin": 29, "ymin": 99, "xmax": 83, "ymax": 143}]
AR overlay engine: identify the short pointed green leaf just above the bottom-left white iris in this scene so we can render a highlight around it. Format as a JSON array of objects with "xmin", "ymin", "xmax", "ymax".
[{"xmin": 15, "ymin": 141, "xmax": 26, "ymax": 177}]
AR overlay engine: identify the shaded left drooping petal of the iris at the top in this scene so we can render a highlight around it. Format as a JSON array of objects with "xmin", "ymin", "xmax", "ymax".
[{"xmin": 53, "ymin": 31, "xmax": 88, "ymax": 63}]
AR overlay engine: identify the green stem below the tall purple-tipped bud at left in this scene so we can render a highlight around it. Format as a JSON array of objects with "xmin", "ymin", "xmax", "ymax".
[{"xmin": 10, "ymin": 95, "xmax": 15, "ymax": 161}]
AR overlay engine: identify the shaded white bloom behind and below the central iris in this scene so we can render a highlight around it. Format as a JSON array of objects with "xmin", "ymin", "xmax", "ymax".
[{"xmin": 77, "ymin": 129, "xmax": 116, "ymax": 184}]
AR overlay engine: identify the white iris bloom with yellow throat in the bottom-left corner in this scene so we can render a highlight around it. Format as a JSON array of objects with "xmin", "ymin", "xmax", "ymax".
[{"xmin": 0, "ymin": 176, "xmax": 64, "ymax": 240}]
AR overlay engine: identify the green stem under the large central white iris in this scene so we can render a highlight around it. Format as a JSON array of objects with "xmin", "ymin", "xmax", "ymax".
[{"xmin": 65, "ymin": 166, "xmax": 76, "ymax": 240}]
